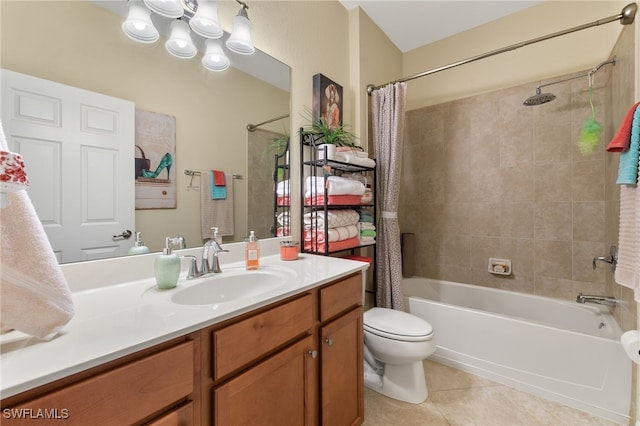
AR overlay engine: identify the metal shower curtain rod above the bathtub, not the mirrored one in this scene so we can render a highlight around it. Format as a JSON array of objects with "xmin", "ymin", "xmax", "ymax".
[{"xmin": 367, "ymin": 3, "xmax": 638, "ymax": 95}]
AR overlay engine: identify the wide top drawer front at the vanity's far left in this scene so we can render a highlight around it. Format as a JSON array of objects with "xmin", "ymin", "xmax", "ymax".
[{"xmin": 3, "ymin": 341, "xmax": 194, "ymax": 426}]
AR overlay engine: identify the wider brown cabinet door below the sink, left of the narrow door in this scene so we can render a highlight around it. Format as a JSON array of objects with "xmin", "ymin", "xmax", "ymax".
[{"xmin": 212, "ymin": 336, "xmax": 317, "ymax": 426}]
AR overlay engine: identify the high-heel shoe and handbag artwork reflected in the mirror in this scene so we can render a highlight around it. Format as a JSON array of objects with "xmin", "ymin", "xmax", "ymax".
[{"xmin": 135, "ymin": 109, "xmax": 176, "ymax": 210}]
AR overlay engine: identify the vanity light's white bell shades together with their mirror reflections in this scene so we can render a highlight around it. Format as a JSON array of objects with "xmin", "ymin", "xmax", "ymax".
[{"xmin": 122, "ymin": 0, "xmax": 255, "ymax": 71}]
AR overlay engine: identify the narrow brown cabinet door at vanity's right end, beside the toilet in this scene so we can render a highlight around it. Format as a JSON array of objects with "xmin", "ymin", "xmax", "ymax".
[{"xmin": 320, "ymin": 306, "xmax": 364, "ymax": 426}]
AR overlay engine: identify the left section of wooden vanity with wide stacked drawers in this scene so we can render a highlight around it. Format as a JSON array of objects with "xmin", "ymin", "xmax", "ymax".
[{"xmin": 2, "ymin": 338, "xmax": 197, "ymax": 426}]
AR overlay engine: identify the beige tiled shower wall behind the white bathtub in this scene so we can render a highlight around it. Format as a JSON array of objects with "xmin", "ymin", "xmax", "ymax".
[{"xmin": 399, "ymin": 27, "xmax": 634, "ymax": 328}]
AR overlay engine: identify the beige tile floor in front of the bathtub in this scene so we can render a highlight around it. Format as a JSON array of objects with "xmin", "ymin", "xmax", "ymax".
[{"xmin": 364, "ymin": 360, "xmax": 619, "ymax": 426}]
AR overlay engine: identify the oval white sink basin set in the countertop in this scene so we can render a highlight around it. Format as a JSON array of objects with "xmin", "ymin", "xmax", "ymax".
[{"xmin": 171, "ymin": 269, "xmax": 296, "ymax": 305}]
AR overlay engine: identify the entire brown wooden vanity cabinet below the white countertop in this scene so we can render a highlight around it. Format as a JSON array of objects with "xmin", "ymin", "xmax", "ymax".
[{"xmin": 1, "ymin": 273, "xmax": 364, "ymax": 426}]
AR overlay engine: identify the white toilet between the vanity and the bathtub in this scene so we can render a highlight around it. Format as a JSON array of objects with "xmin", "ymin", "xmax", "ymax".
[{"xmin": 364, "ymin": 308, "xmax": 436, "ymax": 404}]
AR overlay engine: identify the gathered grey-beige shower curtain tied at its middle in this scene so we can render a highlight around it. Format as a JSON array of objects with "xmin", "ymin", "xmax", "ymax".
[{"xmin": 371, "ymin": 83, "xmax": 407, "ymax": 310}]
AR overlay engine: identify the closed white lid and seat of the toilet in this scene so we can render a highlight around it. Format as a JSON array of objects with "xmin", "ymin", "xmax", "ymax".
[{"xmin": 363, "ymin": 308, "xmax": 433, "ymax": 341}]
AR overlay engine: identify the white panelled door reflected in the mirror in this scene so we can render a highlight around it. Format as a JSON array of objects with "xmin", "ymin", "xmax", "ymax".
[{"xmin": 0, "ymin": 69, "xmax": 135, "ymax": 263}]
